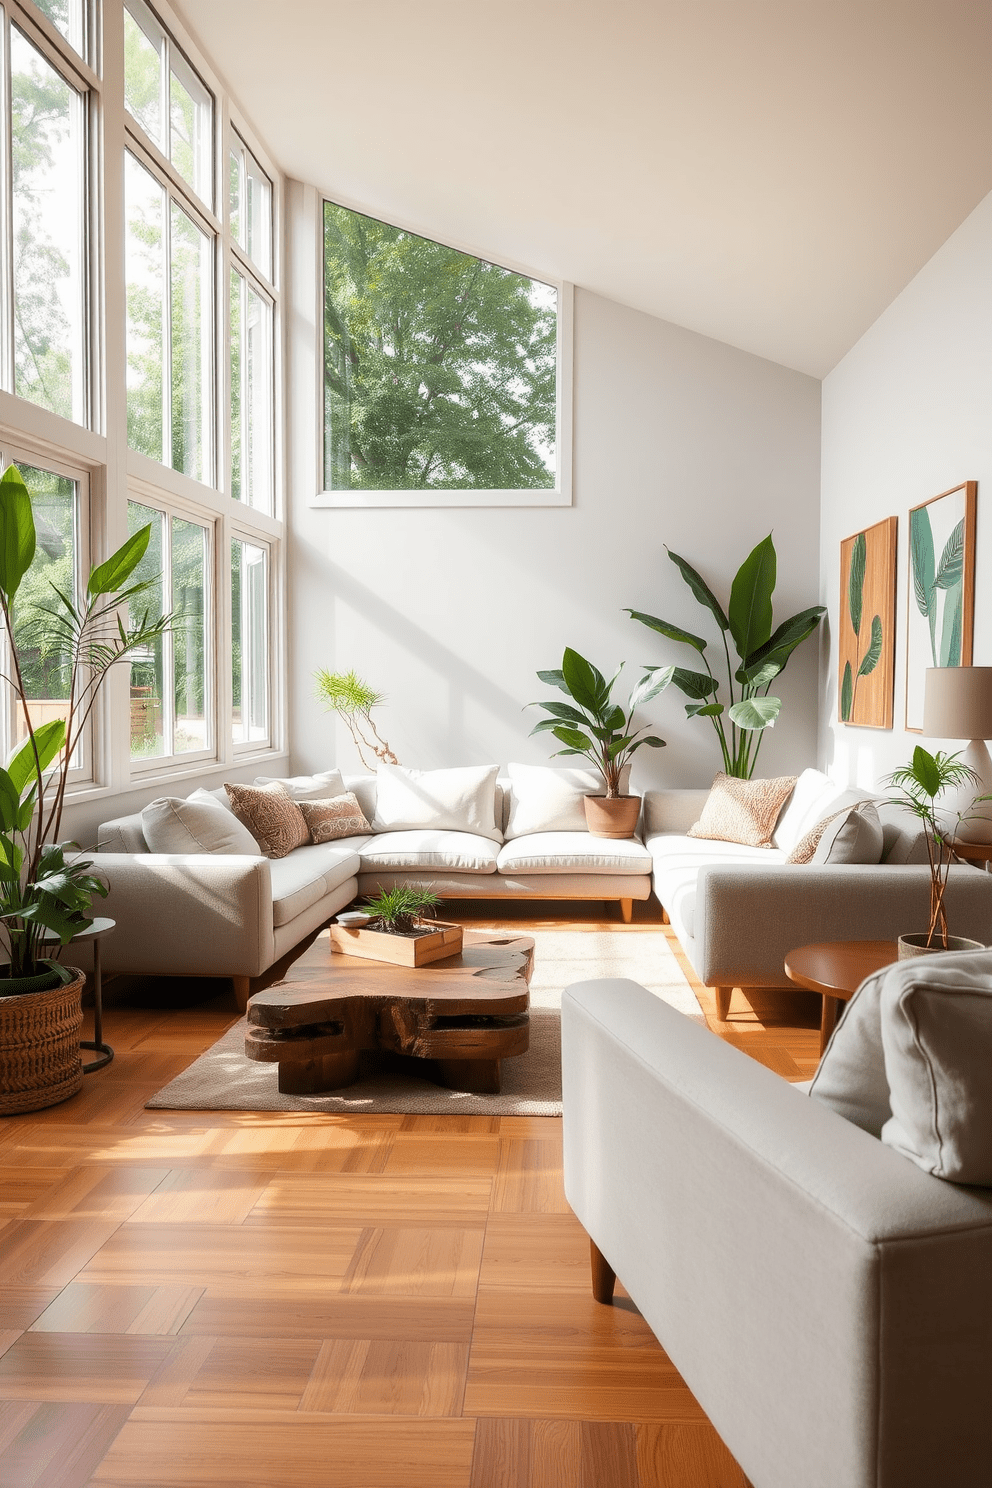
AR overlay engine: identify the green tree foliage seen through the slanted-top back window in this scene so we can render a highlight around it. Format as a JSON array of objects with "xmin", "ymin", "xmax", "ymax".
[{"xmin": 324, "ymin": 202, "xmax": 556, "ymax": 491}]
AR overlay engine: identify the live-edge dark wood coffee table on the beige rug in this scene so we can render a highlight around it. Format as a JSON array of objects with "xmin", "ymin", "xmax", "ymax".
[{"xmin": 244, "ymin": 930, "xmax": 534, "ymax": 1095}]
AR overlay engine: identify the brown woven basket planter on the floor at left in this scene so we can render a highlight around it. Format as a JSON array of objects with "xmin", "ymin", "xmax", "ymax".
[{"xmin": 0, "ymin": 967, "xmax": 86, "ymax": 1116}]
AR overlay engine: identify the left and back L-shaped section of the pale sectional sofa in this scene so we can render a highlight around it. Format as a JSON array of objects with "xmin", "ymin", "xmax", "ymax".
[{"xmin": 89, "ymin": 766, "xmax": 651, "ymax": 1004}]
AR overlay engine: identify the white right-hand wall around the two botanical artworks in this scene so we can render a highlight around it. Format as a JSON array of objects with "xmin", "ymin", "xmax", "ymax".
[{"xmin": 819, "ymin": 195, "xmax": 992, "ymax": 786}]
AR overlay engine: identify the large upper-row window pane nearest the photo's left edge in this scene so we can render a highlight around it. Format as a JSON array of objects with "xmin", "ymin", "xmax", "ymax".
[{"xmin": 0, "ymin": 12, "xmax": 89, "ymax": 424}]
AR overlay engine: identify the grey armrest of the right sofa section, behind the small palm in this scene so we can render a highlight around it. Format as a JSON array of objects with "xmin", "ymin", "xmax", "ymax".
[{"xmin": 693, "ymin": 863, "xmax": 992, "ymax": 987}]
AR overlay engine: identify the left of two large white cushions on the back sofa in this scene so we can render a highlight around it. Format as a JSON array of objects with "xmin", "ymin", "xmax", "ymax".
[{"xmin": 372, "ymin": 765, "xmax": 503, "ymax": 842}]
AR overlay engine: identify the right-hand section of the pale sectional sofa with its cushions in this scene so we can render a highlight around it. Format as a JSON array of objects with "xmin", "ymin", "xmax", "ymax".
[{"xmin": 641, "ymin": 769, "xmax": 992, "ymax": 1018}]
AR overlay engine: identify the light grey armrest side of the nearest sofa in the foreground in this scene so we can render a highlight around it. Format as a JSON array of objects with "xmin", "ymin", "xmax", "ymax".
[{"xmin": 562, "ymin": 981, "xmax": 992, "ymax": 1488}]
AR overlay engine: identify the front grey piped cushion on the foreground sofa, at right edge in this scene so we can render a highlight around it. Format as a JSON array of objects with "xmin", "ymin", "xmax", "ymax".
[{"xmin": 880, "ymin": 951, "xmax": 992, "ymax": 1187}]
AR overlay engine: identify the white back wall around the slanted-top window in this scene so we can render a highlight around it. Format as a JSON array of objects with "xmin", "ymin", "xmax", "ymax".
[{"xmin": 289, "ymin": 279, "xmax": 819, "ymax": 787}]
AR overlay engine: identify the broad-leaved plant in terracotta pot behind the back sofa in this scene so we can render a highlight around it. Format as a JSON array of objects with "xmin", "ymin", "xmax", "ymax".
[{"xmin": 528, "ymin": 646, "xmax": 665, "ymax": 838}]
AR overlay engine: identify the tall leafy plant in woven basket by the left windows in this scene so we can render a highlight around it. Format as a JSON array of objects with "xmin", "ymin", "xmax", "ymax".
[{"xmin": 0, "ymin": 466, "xmax": 173, "ymax": 1113}]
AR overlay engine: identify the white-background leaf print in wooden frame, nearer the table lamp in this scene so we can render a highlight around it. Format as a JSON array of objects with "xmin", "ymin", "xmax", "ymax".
[{"xmin": 906, "ymin": 481, "xmax": 979, "ymax": 734}]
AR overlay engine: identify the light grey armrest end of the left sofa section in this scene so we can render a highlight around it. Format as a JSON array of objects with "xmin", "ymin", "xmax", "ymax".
[{"xmin": 80, "ymin": 853, "xmax": 275, "ymax": 976}]
